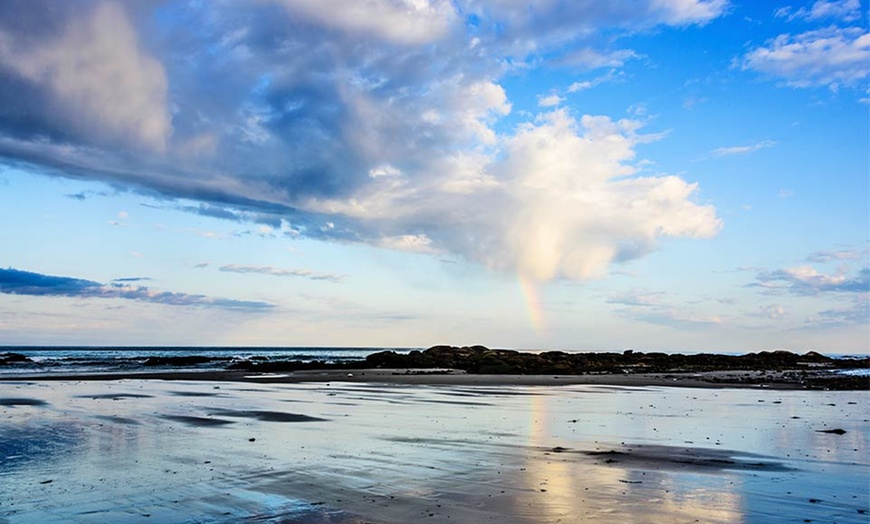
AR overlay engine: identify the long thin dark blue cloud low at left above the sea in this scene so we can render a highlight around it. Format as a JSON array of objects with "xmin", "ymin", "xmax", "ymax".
[{"xmin": 0, "ymin": 268, "xmax": 275, "ymax": 311}]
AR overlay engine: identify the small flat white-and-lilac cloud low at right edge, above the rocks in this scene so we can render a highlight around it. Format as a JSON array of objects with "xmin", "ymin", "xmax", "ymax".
[{"xmin": 752, "ymin": 266, "xmax": 870, "ymax": 296}]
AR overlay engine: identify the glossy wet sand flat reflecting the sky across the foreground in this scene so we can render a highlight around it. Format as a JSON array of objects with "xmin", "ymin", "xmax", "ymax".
[{"xmin": 0, "ymin": 370, "xmax": 870, "ymax": 523}]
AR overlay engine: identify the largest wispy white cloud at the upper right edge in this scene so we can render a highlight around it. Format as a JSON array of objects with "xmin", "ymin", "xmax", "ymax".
[{"xmin": 740, "ymin": 26, "xmax": 870, "ymax": 91}]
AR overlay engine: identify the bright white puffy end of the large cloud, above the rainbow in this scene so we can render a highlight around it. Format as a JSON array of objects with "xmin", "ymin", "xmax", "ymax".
[{"xmin": 309, "ymin": 109, "xmax": 721, "ymax": 280}]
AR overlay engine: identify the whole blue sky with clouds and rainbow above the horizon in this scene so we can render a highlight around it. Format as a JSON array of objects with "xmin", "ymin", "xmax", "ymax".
[{"xmin": 0, "ymin": 0, "xmax": 870, "ymax": 354}]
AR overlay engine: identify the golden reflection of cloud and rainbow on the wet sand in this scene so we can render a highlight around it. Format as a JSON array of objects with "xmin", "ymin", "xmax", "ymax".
[{"xmin": 515, "ymin": 397, "xmax": 742, "ymax": 523}]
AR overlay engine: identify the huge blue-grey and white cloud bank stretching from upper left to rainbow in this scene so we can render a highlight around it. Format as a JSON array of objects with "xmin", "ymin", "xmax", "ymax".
[{"xmin": 0, "ymin": 0, "xmax": 728, "ymax": 279}]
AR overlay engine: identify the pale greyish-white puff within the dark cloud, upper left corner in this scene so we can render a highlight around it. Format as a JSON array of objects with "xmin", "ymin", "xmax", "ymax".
[{"xmin": 0, "ymin": 2, "xmax": 172, "ymax": 152}]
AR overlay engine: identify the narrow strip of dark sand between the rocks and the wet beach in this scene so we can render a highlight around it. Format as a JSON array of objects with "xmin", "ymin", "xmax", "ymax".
[{"xmin": 0, "ymin": 368, "xmax": 870, "ymax": 390}]
